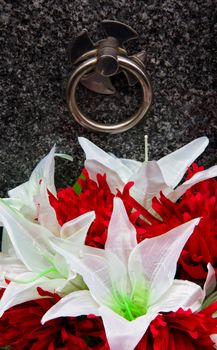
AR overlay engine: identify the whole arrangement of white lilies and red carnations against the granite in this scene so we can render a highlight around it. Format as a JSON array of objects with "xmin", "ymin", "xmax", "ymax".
[{"xmin": 0, "ymin": 137, "xmax": 217, "ymax": 350}]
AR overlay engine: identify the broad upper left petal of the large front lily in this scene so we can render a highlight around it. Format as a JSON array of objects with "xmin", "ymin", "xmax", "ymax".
[{"xmin": 50, "ymin": 238, "xmax": 128, "ymax": 305}]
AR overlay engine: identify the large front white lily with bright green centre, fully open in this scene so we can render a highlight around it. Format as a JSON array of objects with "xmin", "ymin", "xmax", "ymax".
[{"xmin": 42, "ymin": 198, "xmax": 204, "ymax": 350}]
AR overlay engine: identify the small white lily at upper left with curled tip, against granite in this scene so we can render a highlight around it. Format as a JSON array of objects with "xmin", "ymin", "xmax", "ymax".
[{"xmin": 5, "ymin": 146, "xmax": 72, "ymax": 235}]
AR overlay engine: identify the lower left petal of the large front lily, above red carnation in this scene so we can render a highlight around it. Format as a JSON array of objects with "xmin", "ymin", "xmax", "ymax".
[{"xmin": 41, "ymin": 290, "xmax": 99, "ymax": 324}]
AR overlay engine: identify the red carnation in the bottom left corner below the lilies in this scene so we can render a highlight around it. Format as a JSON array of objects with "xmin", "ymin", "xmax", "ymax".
[{"xmin": 0, "ymin": 293, "xmax": 109, "ymax": 350}]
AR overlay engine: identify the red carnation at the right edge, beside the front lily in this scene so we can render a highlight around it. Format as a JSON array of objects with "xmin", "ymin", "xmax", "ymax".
[{"xmin": 139, "ymin": 165, "xmax": 217, "ymax": 283}]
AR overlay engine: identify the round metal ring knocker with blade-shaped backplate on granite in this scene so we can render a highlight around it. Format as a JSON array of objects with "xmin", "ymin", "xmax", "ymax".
[{"xmin": 67, "ymin": 20, "xmax": 152, "ymax": 134}]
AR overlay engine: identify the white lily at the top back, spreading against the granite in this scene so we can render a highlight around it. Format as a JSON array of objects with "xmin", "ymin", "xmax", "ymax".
[{"xmin": 79, "ymin": 137, "xmax": 217, "ymax": 210}]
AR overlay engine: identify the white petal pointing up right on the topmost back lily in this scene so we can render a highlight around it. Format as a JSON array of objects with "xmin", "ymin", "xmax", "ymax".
[{"xmin": 158, "ymin": 137, "xmax": 209, "ymax": 188}]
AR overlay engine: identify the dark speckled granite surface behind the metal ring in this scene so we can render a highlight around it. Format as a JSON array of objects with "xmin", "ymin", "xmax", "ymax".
[{"xmin": 0, "ymin": 0, "xmax": 217, "ymax": 195}]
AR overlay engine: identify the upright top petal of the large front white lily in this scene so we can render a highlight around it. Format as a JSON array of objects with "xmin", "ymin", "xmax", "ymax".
[{"xmin": 105, "ymin": 198, "xmax": 137, "ymax": 265}]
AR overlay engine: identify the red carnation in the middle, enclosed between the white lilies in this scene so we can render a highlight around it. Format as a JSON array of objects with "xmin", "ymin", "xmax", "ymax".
[{"xmin": 49, "ymin": 169, "xmax": 144, "ymax": 248}]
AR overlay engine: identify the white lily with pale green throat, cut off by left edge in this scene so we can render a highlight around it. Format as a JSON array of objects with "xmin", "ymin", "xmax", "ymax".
[{"xmin": 0, "ymin": 200, "xmax": 95, "ymax": 315}]
